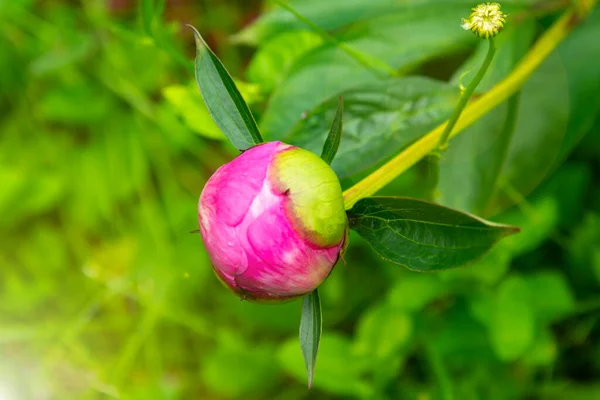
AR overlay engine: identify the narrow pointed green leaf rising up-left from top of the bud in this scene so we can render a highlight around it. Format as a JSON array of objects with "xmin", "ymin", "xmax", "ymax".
[{"xmin": 189, "ymin": 25, "xmax": 263, "ymax": 150}]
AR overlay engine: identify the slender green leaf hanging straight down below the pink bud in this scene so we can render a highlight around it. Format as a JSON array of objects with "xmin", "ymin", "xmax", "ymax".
[{"xmin": 300, "ymin": 289, "xmax": 323, "ymax": 389}]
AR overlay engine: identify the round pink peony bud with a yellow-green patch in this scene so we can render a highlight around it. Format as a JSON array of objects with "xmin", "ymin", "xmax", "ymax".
[{"xmin": 198, "ymin": 142, "xmax": 348, "ymax": 301}]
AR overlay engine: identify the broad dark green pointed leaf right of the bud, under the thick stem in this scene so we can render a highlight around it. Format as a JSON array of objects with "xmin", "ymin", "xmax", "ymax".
[{"xmin": 348, "ymin": 197, "xmax": 519, "ymax": 272}]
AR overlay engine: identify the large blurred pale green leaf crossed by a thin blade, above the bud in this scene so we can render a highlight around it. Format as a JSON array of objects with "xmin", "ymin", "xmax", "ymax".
[{"xmin": 261, "ymin": 3, "xmax": 475, "ymax": 140}]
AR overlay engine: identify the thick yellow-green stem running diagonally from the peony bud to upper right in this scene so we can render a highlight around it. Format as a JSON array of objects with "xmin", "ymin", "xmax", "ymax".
[{"xmin": 344, "ymin": 11, "xmax": 574, "ymax": 209}]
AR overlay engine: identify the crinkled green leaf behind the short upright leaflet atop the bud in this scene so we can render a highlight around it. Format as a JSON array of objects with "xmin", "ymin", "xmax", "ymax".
[{"xmin": 285, "ymin": 76, "xmax": 458, "ymax": 178}]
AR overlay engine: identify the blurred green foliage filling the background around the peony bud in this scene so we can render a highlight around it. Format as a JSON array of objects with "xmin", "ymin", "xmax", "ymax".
[{"xmin": 0, "ymin": 0, "xmax": 600, "ymax": 400}]
